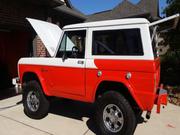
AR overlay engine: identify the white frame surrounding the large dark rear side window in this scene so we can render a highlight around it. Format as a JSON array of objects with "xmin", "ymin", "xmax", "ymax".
[{"xmin": 86, "ymin": 24, "xmax": 154, "ymax": 60}]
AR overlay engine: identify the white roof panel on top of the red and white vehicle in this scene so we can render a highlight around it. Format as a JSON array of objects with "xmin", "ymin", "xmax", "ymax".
[{"xmin": 63, "ymin": 18, "xmax": 150, "ymax": 29}]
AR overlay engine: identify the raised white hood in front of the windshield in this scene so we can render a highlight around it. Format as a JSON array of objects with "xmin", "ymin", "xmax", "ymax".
[{"xmin": 26, "ymin": 18, "xmax": 62, "ymax": 57}]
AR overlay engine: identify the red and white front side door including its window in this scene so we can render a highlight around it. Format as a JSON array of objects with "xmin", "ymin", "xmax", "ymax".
[{"xmin": 45, "ymin": 30, "xmax": 86, "ymax": 96}]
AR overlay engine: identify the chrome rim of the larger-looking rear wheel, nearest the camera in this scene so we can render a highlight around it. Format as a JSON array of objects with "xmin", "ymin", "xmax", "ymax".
[{"xmin": 103, "ymin": 104, "xmax": 124, "ymax": 133}]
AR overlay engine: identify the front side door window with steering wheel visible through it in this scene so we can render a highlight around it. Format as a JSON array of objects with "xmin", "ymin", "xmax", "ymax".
[{"xmin": 57, "ymin": 30, "xmax": 86, "ymax": 58}]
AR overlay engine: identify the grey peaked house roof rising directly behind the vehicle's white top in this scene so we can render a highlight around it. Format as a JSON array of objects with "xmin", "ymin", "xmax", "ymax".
[{"xmin": 86, "ymin": 0, "xmax": 159, "ymax": 22}]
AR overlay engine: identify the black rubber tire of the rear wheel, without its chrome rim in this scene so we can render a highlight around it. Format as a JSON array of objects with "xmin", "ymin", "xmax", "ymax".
[{"xmin": 95, "ymin": 91, "xmax": 137, "ymax": 135}]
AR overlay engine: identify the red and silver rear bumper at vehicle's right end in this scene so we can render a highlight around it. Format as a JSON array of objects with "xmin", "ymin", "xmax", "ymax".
[{"xmin": 155, "ymin": 88, "xmax": 168, "ymax": 113}]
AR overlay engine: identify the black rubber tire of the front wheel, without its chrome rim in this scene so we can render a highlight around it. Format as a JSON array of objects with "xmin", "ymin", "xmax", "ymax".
[{"xmin": 23, "ymin": 81, "xmax": 49, "ymax": 119}]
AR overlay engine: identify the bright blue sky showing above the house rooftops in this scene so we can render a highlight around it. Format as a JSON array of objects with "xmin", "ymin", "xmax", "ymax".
[{"xmin": 71, "ymin": 0, "xmax": 167, "ymax": 16}]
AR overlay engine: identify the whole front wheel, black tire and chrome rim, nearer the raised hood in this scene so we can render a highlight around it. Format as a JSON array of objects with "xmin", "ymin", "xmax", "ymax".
[{"xmin": 23, "ymin": 81, "xmax": 49, "ymax": 119}]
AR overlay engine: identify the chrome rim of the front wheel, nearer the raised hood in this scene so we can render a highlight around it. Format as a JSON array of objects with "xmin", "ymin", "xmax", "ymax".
[{"xmin": 27, "ymin": 91, "xmax": 40, "ymax": 112}]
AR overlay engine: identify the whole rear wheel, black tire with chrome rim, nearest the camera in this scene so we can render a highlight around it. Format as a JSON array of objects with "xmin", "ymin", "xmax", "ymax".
[{"xmin": 95, "ymin": 91, "xmax": 136, "ymax": 135}]
